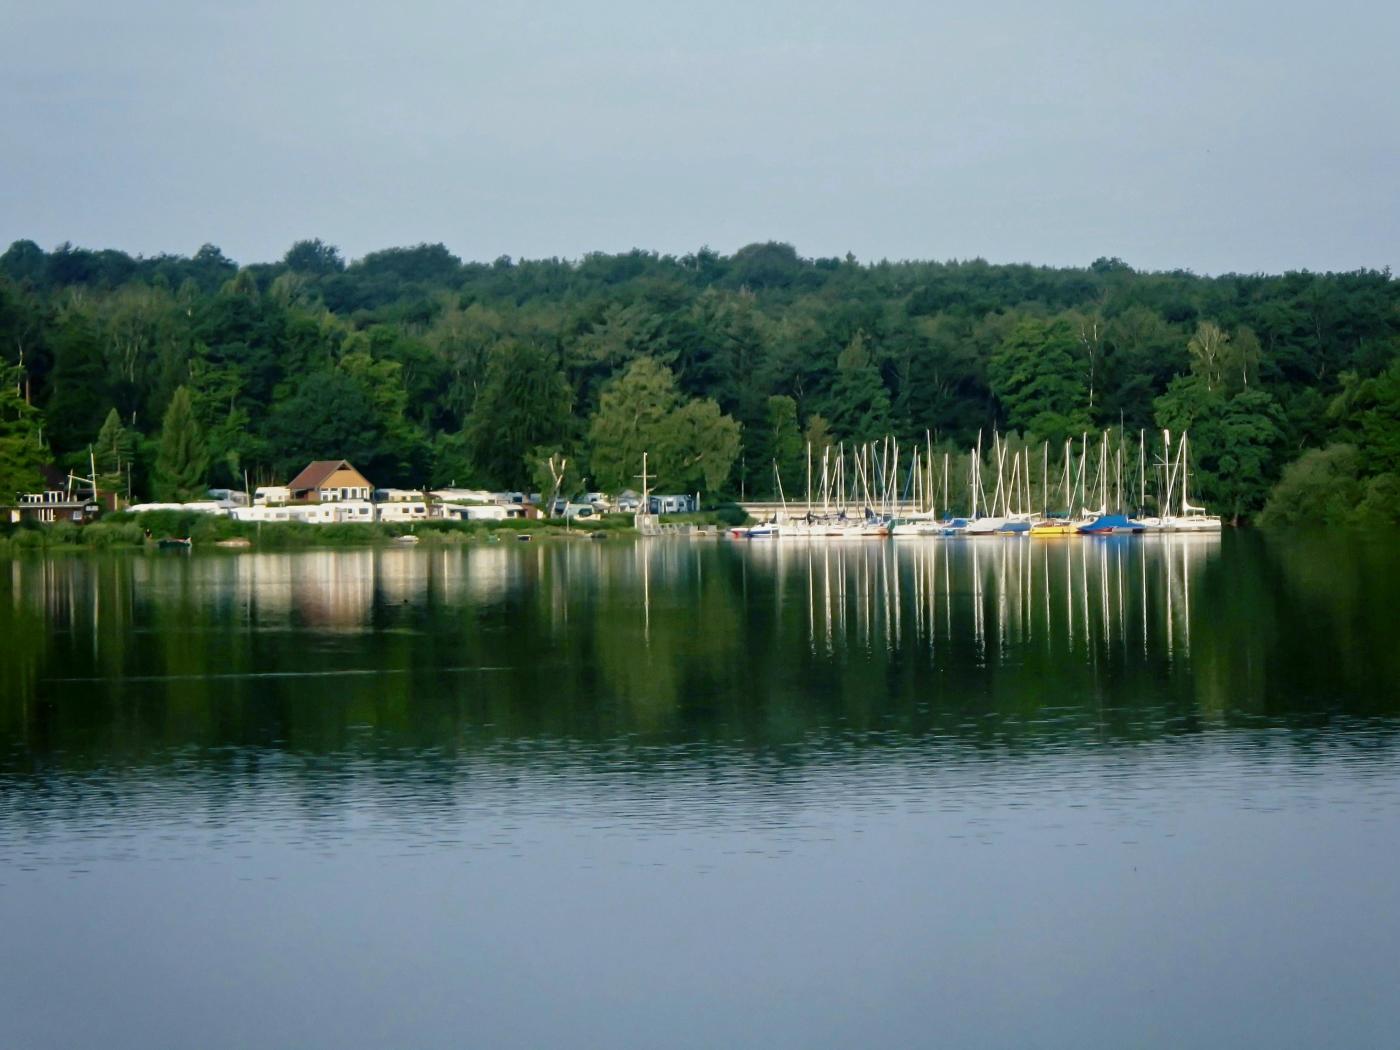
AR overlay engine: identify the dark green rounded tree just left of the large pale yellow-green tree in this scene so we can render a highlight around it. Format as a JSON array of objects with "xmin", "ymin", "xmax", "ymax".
[{"xmin": 466, "ymin": 343, "xmax": 573, "ymax": 486}]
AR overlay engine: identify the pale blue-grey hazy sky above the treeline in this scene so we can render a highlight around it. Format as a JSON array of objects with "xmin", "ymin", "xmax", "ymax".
[{"xmin": 0, "ymin": 0, "xmax": 1400, "ymax": 273}]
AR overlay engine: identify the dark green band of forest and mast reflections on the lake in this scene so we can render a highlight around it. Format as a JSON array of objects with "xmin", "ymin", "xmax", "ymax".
[{"xmin": 0, "ymin": 535, "xmax": 1400, "ymax": 763}]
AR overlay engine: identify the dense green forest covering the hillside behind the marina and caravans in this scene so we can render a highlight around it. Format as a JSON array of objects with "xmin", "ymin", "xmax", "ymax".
[{"xmin": 0, "ymin": 233, "xmax": 1400, "ymax": 524}]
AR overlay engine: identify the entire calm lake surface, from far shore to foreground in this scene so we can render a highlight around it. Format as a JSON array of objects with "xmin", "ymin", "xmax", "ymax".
[{"xmin": 0, "ymin": 532, "xmax": 1400, "ymax": 1050}]
